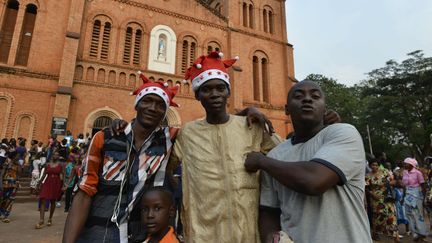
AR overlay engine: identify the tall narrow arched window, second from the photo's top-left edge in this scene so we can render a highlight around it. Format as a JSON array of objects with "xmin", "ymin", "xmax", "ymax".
[{"xmin": 15, "ymin": 4, "xmax": 37, "ymax": 66}]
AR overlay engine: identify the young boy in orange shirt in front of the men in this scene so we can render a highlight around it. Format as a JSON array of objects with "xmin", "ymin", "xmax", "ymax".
[{"xmin": 140, "ymin": 187, "xmax": 179, "ymax": 243}]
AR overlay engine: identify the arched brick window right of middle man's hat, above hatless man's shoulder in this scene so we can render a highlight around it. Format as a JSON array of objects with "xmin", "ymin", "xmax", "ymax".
[{"xmin": 252, "ymin": 51, "xmax": 270, "ymax": 103}]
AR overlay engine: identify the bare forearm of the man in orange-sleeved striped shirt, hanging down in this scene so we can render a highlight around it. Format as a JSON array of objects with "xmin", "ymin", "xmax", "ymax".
[{"xmin": 63, "ymin": 190, "xmax": 92, "ymax": 243}]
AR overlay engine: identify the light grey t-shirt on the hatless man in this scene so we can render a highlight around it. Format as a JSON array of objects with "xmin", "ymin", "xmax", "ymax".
[{"xmin": 260, "ymin": 123, "xmax": 372, "ymax": 243}]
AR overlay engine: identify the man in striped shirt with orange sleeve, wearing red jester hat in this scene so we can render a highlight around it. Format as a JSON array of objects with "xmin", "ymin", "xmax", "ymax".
[{"xmin": 63, "ymin": 73, "xmax": 178, "ymax": 242}]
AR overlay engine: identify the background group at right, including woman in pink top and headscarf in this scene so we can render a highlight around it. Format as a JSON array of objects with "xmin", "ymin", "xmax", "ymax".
[{"xmin": 366, "ymin": 153, "xmax": 432, "ymax": 241}]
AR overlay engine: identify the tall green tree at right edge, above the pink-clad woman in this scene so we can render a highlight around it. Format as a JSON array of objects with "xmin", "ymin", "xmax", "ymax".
[{"xmin": 360, "ymin": 51, "xmax": 432, "ymax": 160}]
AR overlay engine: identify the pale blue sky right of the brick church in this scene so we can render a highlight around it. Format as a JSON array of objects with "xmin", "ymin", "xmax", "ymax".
[{"xmin": 286, "ymin": 0, "xmax": 432, "ymax": 86}]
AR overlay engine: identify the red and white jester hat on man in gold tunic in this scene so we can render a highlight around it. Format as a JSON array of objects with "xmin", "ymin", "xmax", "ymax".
[{"xmin": 184, "ymin": 51, "xmax": 239, "ymax": 92}]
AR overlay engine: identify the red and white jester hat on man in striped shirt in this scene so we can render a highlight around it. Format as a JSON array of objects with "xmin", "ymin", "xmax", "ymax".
[{"xmin": 131, "ymin": 71, "xmax": 179, "ymax": 107}]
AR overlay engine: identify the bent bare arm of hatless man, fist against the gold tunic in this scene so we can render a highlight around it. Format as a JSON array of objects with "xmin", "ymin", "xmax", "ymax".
[{"xmin": 245, "ymin": 152, "xmax": 341, "ymax": 196}]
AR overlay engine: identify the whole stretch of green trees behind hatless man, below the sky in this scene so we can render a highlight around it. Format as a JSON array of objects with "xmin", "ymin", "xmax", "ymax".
[{"xmin": 307, "ymin": 51, "xmax": 432, "ymax": 161}]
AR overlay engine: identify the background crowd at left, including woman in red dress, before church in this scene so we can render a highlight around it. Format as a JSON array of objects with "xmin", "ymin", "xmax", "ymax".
[{"xmin": 0, "ymin": 131, "xmax": 91, "ymax": 229}]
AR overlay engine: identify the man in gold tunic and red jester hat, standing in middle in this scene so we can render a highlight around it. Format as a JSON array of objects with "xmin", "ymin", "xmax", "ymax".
[{"xmin": 169, "ymin": 52, "xmax": 281, "ymax": 243}]
